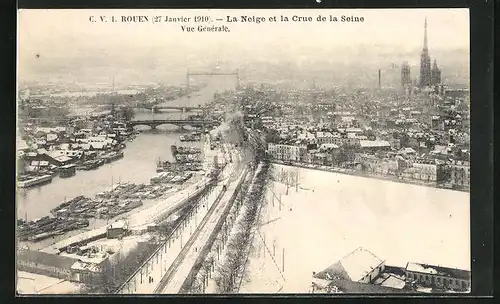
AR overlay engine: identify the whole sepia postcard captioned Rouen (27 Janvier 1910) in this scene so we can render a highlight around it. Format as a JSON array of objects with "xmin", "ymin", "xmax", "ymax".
[{"xmin": 15, "ymin": 9, "xmax": 473, "ymax": 296}]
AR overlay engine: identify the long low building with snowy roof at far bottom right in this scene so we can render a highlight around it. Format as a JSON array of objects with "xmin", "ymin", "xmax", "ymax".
[{"xmin": 405, "ymin": 262, "xmax": 471, "ymax": 291}]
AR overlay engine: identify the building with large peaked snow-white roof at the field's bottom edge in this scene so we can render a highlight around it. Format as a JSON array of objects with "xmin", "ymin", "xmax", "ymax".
[{"xmin": 316, "ymin": 247, "xmax": 385, "ymax": 283}]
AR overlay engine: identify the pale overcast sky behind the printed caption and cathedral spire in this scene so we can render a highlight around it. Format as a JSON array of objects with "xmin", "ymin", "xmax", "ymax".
[{"xmin": 18, "ymin": 9, "xmax": 469, "ymax": 84}]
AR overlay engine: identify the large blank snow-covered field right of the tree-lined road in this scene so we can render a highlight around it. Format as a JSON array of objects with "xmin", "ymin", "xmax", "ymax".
[{"xmin": 240, "ymin": 165, "xmax": 470, "ymax": 293}]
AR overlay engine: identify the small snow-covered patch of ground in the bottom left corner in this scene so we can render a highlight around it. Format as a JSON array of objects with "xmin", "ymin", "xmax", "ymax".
[{"xmin": 17, "ymin": 271, "xmax": 81, "ymax": 295}]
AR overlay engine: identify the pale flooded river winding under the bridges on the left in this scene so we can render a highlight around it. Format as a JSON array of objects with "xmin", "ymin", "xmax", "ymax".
[{"xmin": 16, "ymin": 85, "xmax": 232, "ymax": 220}]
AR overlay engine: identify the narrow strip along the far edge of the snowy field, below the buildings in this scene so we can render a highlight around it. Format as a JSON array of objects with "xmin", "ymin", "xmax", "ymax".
[{"xmin": 272, "ymin": 160, "xmax": 470, "ymax": 193}]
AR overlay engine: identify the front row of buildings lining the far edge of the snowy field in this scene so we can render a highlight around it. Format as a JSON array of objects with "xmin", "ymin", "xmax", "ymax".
[{"xmin": 267, "ymin": 140, "xmax": 470, "ymax": 189}]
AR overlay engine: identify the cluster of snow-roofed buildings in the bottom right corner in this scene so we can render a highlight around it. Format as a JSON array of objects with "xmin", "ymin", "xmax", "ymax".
[{"xmin": 312, "ymin": 247, "xmax": 471, "ymax": 294}]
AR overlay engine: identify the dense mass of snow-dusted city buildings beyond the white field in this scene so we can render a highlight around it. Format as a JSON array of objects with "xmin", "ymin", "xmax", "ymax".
[{"xmin": 244, "ymin": 62, "xmax": 470, "ymax": 190}]
